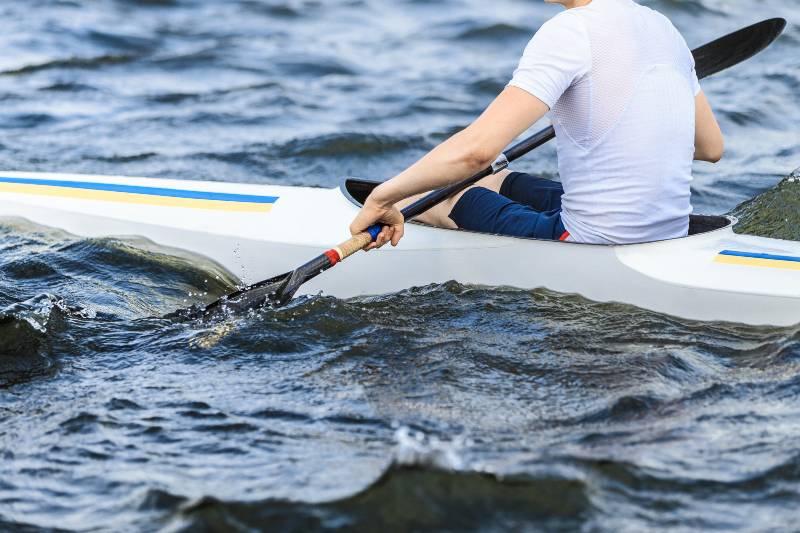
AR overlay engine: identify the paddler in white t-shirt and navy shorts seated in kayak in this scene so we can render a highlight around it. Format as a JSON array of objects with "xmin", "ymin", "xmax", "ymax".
[{"xmin": 350, "ymin": 0, "xmax": 724, "ymax": 248}]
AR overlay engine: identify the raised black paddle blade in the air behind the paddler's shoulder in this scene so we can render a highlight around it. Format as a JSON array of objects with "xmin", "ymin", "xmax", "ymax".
[{"xmin": 692, "ymin": 18, "xmax": 786, "ymax": 78}]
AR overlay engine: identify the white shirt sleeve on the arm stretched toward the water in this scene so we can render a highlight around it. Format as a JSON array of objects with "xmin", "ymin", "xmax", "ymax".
[{"xmin": 508, "ymin": 12, "xmax": 592, "ymax": 109}]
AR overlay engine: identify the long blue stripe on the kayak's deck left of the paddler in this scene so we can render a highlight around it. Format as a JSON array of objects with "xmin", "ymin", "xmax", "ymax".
[{"xmin": 0, "ymin": 177, "xmax": 278, "ymax": 204}]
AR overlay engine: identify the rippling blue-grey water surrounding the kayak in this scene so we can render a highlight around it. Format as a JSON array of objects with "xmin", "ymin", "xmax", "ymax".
[{"xmin": 0, "ymin": 0, "xmax": 800, "ymax": 531}]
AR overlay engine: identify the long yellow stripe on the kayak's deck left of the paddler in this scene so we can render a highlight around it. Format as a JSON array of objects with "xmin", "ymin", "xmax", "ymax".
[{"xmin": 0, "ymin": 182, "xmax": 274, "ymax": 213}]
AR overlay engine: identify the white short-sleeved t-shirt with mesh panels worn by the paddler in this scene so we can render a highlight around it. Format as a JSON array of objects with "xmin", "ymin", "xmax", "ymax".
[{"xmin": 509, "ymin": 0, "xmax": 700, "ymax": 244}]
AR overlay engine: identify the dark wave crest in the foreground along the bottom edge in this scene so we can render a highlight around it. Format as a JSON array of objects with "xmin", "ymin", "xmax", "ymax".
[{"xmin": 176, "ymin": 466, "xmax": 591, "ymax": 531}]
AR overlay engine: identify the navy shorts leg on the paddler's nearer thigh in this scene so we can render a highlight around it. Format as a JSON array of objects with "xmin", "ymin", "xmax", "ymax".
[{"xmin": 450, "ymin": 187, "xmax": 566, "ymax": 240}]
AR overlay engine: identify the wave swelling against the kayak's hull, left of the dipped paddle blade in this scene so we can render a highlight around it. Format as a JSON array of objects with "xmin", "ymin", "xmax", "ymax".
[{"xmin": 0, "ymin": 220, "xmax": 238, "ymax": 318}]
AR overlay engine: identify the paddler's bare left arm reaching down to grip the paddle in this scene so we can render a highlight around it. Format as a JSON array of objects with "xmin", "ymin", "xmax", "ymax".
[{"xmin": 350, "ymin": 87, "xmax": 549, "ymax": 246}]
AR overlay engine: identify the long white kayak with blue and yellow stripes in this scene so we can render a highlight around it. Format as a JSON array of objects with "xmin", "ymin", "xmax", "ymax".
[{"xmin": 0, "ymin": 172, "xmax": 800, "ymax": 326}]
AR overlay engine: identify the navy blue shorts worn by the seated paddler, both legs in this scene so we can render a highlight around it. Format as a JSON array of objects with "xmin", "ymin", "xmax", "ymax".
[{"xmin": 450, "ymin": 172, "xmax": 569, "ymax": 241}]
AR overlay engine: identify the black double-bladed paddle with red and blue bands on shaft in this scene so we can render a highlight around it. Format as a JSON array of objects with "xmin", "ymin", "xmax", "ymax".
[{"xmin": 203, "ymin": 18, "xmax": 786, "ymax": 314}]
